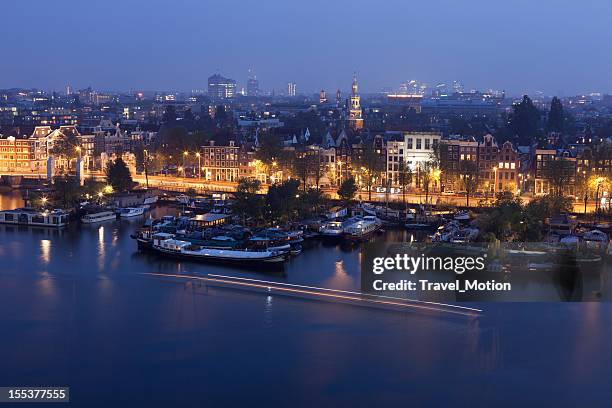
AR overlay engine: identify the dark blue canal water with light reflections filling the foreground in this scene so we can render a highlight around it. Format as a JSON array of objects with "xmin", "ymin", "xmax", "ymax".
[{"xmin": 0, "ymin": 194, "xmax": 612, "ymax": 407}]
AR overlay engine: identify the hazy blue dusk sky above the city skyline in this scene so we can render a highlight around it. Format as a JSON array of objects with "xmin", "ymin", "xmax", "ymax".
[{"xmin": 0, "ymin": 0, "xmax": 612, "ymax": 95}]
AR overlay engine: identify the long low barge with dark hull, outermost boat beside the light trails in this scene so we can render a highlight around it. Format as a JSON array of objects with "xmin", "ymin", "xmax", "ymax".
[{"xmin": 152, "ymin": 234, "xmax": 286, "ymax": 266}]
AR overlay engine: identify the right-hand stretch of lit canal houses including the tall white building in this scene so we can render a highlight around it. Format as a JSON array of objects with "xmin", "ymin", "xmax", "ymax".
[{"xmin": 278, "ymin": 130, "xmax": 612, "ymax": 195}]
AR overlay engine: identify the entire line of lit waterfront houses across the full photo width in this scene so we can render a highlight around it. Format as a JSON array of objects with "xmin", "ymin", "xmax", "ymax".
[{"xmin": 0, "ymin": 120, "xmax": 612, "ymax": 195}]
